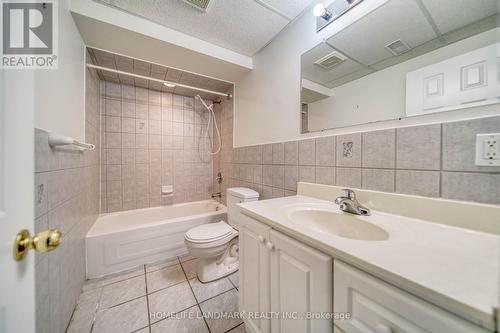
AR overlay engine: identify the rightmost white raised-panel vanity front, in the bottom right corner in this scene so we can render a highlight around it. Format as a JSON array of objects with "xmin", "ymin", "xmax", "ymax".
[{"xmin": 333, "ymin": 260, "xmax": 487, "ymax": 333}]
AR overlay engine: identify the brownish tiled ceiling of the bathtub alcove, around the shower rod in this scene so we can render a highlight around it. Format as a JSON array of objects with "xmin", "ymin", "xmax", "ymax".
[{"xmin": 87, "ymin": 47, "xmax": 233, "ymax": 101}]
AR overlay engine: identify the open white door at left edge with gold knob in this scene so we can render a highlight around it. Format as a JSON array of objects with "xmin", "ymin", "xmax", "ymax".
[{"xmin": 0, "ymin": 70, "xmax": 35, "ymax": 333}]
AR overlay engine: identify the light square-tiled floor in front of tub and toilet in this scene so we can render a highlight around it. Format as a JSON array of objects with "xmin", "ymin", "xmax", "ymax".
[{"xmin": 67, "ymin": 256, "xmax": 245, "ymax": 333}]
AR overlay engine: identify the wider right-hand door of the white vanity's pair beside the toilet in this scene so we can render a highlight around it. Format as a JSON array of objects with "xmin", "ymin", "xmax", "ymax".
[{"xmin": 266, "ymin": 230, "xmax": 333, "ymax": 333}]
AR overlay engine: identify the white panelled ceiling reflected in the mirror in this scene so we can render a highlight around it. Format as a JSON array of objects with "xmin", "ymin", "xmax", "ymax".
[{"xmin": 302, "ymin": 0, "xmax": 500, "ymax": 88}]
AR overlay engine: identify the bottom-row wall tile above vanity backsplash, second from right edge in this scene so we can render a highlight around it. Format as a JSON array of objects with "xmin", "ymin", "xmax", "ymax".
[{"xmin": 396, "ymin": 170, "xmax": 440, "ymax": 197}]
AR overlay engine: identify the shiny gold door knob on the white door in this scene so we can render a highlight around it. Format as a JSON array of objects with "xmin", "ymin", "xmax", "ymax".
[{"xmin": 14, "ymin": 229, "xmax": 62, "ymax": 261}]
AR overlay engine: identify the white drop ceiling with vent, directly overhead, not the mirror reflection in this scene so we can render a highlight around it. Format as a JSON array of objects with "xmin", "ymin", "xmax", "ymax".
[{"xmin": 95, "ymin": 0, "xmax": 313, "ymax": 56}]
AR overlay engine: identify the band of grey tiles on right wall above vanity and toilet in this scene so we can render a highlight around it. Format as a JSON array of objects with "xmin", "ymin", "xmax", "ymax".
[{"xmin": 228, "ymin": 115, "xmax": 500, "ymax": 204}]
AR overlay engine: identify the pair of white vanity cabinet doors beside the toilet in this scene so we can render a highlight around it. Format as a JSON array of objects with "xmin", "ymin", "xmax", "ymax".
[{"xmin": 239, "ymin": 216, "xmax": 333, "ymax": 333}]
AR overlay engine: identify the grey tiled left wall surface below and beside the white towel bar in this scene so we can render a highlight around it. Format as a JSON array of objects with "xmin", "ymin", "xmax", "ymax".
[{"xmin": 35, "ymin": 66, "xmax": 100, "ymax": 333}]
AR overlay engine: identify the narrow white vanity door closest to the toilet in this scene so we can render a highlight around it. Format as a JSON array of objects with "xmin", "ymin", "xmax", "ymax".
[{"xmin": 239, "ymin": 215, "xmax": 271, "ymax": 333}]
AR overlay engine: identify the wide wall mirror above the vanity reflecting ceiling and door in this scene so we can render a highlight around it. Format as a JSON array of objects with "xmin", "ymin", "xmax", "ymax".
[{"xmin": 300, "ymin": 0, "xmax": 500, "ymax": 133}]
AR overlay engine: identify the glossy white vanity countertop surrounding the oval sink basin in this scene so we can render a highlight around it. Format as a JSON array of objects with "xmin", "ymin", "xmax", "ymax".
[{"xmin": 239, "ymin": 195, "xmax": 500, "ymax": 329}]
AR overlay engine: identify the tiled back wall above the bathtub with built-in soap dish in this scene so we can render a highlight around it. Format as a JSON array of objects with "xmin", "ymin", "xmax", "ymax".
[{"xmin": 101, "ymin": 82, "xmax": 212, "ymax": 213}]
